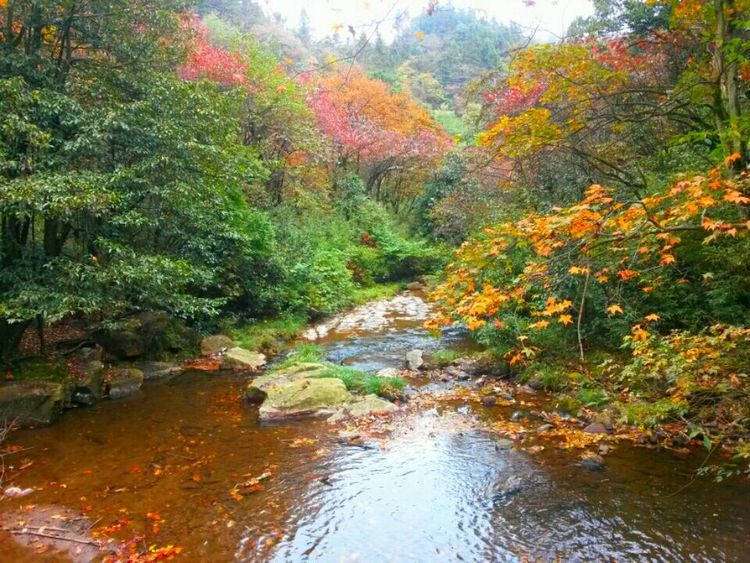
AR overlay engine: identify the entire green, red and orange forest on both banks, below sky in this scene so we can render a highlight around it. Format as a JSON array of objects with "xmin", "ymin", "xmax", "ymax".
[{"xmin": 0, "ymin": 0, "xmax": 750, "ymax": 476}]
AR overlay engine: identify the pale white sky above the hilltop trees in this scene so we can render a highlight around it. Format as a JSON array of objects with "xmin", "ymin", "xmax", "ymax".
[{"xmin": 259, "ymin": 0, "xmax": 593, "ymax": 40}]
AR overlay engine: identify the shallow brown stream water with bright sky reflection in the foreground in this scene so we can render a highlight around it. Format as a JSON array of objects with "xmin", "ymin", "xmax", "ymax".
[{"xmin": 0, "ymin": 298, "xmax": 750, "ymax": 562}]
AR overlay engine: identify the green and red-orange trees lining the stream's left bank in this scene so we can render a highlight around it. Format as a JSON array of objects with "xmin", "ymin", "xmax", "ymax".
[{"xmin": 0, "ymin": 0, "xmax": 452, "ymax": 365}]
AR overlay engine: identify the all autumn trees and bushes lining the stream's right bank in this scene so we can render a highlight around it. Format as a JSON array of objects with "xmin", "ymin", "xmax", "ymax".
[{"xmin": 432, "ymin": 0, "xmax": 750, "ymax": 450}]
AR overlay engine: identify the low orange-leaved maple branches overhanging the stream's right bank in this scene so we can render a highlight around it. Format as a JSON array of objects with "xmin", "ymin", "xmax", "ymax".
[{"xmin": 429, "ymin": 155, "xmax": 750, "ymax": 364}]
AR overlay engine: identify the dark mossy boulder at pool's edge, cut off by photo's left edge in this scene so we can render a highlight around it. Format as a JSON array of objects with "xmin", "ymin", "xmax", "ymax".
[{"xmin": 0, "ymin": 381, "xmax": 65, "ymax": 426}]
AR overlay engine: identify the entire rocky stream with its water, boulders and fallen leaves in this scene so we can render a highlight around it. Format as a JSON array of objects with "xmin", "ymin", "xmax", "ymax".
[{"xmin": 0, "ymin": 293, "xmax": 750, "ymax": 562}]
